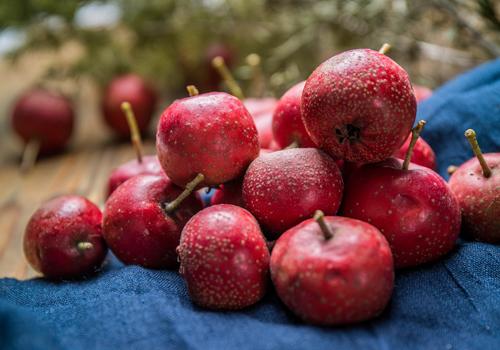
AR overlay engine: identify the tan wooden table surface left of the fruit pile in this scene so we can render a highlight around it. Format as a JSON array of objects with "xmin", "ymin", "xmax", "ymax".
[{"xmin": 0, "ymin": 50, "xmax": 162, "ymax": 279}]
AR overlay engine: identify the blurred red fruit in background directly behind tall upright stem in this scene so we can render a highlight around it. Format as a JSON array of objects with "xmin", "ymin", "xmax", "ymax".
[{"xmin": 101, "ymin": 74, "xmax": 158, "ymax": 138}]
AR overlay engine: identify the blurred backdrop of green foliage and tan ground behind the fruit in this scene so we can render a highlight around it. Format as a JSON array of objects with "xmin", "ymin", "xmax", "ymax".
[{"xmin": 0, "ymin": 0, "xmax": 500, "ymax": 165}]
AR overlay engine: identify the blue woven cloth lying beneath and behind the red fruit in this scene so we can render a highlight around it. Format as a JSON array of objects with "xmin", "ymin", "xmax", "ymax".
[{"xmin": 0, "ymin": 59, "xmax": 500, "ymax": 350}]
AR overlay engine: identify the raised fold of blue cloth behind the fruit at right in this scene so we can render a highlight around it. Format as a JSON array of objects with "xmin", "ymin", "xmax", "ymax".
[{"xmin": 417, "ymin": 59, "xmax": 500, "ymax": 178}]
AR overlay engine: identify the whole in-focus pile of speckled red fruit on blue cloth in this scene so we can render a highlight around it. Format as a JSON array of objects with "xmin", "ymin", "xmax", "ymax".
[{"xmin": 25, "ymin": 45, "xmax": 500, "ymax": 325}]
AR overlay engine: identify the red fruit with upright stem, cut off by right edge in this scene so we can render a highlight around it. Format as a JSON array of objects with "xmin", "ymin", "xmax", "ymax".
[{"xmin": 449, "ymin": 153, "xmax": 500, "ymax": 243}]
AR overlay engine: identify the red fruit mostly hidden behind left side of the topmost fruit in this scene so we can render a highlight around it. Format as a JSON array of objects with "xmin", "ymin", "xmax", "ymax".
[{"xmin": 273, "ymin": 81, "xmax": 316, "ymax": 148}]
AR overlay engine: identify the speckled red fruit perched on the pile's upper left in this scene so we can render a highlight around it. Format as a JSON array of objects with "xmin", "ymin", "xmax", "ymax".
[{"xmin": 156, "ymin": 92, "xmax": 259, "ymax": 187}]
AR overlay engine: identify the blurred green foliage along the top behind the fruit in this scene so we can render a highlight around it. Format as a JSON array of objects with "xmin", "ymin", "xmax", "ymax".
[{"xmin": 0, "ymin": 0, "xmax": 500, "ymax": 94}]
